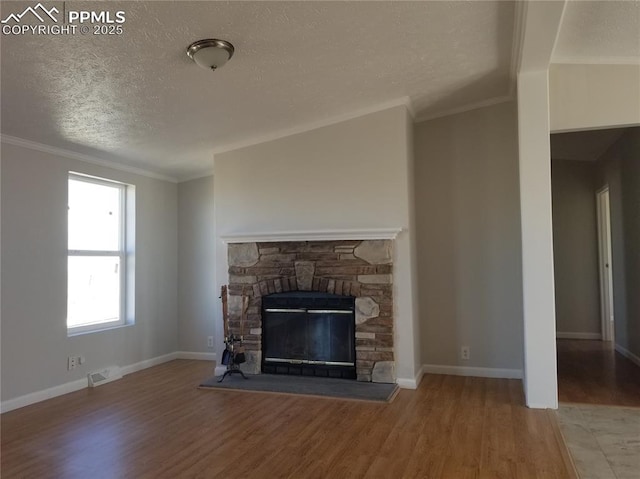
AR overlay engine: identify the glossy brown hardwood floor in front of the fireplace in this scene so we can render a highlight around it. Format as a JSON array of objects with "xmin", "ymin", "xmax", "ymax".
[{"xmin": 1, "ymin": 360, "xmax": 572, "ymax": 479}]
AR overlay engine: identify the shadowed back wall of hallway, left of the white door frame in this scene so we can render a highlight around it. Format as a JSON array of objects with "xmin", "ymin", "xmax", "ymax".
[{"xmin": 551, "ymin": 160, "xmax": 601, "ymax": 334}]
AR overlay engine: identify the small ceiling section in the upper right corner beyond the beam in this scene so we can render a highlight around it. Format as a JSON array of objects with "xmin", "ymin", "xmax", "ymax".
[{"xmin": 552, "ymin": 0, "xmax": 640, "ymax": 64}]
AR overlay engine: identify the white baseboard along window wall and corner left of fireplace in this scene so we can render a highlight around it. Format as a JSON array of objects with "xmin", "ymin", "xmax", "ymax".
[{"xmin": 0, "ymin": 351, "xmax": 218, "ymax": 413}]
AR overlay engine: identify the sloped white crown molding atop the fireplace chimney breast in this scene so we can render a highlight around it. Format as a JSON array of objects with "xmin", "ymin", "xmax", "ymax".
[{"xmin": 213, "ymin": 96, "xmax": 415, "ymax": 155}]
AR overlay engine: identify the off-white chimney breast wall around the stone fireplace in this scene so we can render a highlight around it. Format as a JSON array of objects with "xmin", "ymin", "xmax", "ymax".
[{"xmin": 214, "ymin": 106, "xmax": 418, "ymax": 381}]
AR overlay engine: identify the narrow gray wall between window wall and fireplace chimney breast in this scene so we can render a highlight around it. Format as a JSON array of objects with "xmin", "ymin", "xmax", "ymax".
[{"xmin": 178, "ymin": 176, "xmax": 216, "ymax": 353}]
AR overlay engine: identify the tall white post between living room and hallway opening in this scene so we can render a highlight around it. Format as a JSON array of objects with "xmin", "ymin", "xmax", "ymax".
[{"xmin": 518, "ymin": 71, "xmax": 558, "ymax": 409}]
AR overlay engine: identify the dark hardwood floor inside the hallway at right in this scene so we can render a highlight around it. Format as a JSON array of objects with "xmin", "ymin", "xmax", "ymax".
[{"xmin": 557, "ymin": 339, "xmax": 640, "ymax": 407}]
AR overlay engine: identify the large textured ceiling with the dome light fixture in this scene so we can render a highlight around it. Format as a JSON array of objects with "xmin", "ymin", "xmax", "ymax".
[{"xmin": 1, "ymin": 1, "xmax": 514, "ymax": 177}]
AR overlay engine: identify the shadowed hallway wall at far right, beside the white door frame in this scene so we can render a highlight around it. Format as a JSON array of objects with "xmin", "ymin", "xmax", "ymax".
[{"xmin": 598, "ymin": 127, "xmax": 640, "ymax": 356}]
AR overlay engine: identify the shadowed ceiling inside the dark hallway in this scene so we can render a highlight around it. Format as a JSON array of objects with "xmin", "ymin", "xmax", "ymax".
[{"xmin": 551, "ymin": 128, "xmax": 627, "ymax": 161}]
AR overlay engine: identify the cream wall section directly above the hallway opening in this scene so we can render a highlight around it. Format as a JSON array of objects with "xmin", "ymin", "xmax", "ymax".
[{"xmin": 549, "ymin": 65, "xmax": 640, "ymax": 132}]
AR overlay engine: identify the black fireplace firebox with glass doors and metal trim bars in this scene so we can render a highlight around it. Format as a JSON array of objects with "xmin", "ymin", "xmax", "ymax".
[{"xmin": 262, "ymin": 291, "xmax": 356, "ymax": 379}]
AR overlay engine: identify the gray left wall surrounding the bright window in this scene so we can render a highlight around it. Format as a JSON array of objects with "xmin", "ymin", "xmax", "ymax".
[{"xmin": 1, "ymin": 143, "xmax": 178, "ymax": 401}]
